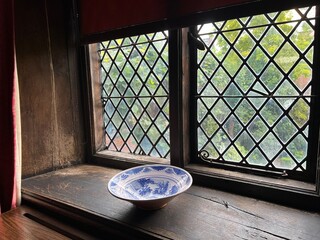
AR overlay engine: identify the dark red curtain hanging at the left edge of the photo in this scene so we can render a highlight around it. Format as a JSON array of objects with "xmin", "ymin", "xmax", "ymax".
[{"xmin": 0, "ymin": 0, "xmax": 16, "ymax": 212}]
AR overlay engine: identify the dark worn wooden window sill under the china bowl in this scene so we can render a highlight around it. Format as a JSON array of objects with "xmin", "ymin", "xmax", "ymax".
[{"xmin": 22, "ymin": 165, "xmax": 320, "ymax": 239}]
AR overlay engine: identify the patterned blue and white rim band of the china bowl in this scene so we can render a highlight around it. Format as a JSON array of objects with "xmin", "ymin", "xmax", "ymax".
[{"xmin": 108, "ymin": 164, "xmax": 193, "ymax": 202}]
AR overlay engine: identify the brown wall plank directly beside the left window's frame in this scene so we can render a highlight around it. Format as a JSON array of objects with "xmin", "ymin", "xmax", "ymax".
[{"xmin": 46, "ymin": 0, "xmax": 84, "ymax": 168}]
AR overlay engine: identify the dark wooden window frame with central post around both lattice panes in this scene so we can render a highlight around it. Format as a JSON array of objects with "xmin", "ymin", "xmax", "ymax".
[{"xmin": 79, "ymin": 1, "xmax": 320, "ymax": 209}]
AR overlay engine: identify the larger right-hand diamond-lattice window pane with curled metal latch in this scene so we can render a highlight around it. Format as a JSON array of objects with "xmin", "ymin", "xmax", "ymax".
[{"xmin": 195, "ymin": 7, "xmax": 316, "ymax": 172}]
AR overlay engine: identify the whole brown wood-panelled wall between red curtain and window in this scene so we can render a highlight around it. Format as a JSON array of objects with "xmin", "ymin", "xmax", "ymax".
[{"xmin": 15, "ymin": 0, "xmax": 84, "ymax": 177}]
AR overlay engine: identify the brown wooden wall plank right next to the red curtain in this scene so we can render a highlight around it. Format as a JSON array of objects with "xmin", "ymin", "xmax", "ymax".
[{"xmin": 15, "ymin": 0, "xmax": 53, "ymax": 175}]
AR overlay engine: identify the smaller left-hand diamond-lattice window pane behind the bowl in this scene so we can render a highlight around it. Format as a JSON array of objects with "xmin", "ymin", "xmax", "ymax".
[{"xmin": 99, "ymin": 31, "xmax": 170, "ymax": 158}]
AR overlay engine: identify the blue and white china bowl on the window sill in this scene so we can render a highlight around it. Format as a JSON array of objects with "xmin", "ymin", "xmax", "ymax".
[{"xmin": 108, "ymin": 164, "xmax": 192, "ymax": 210}]
